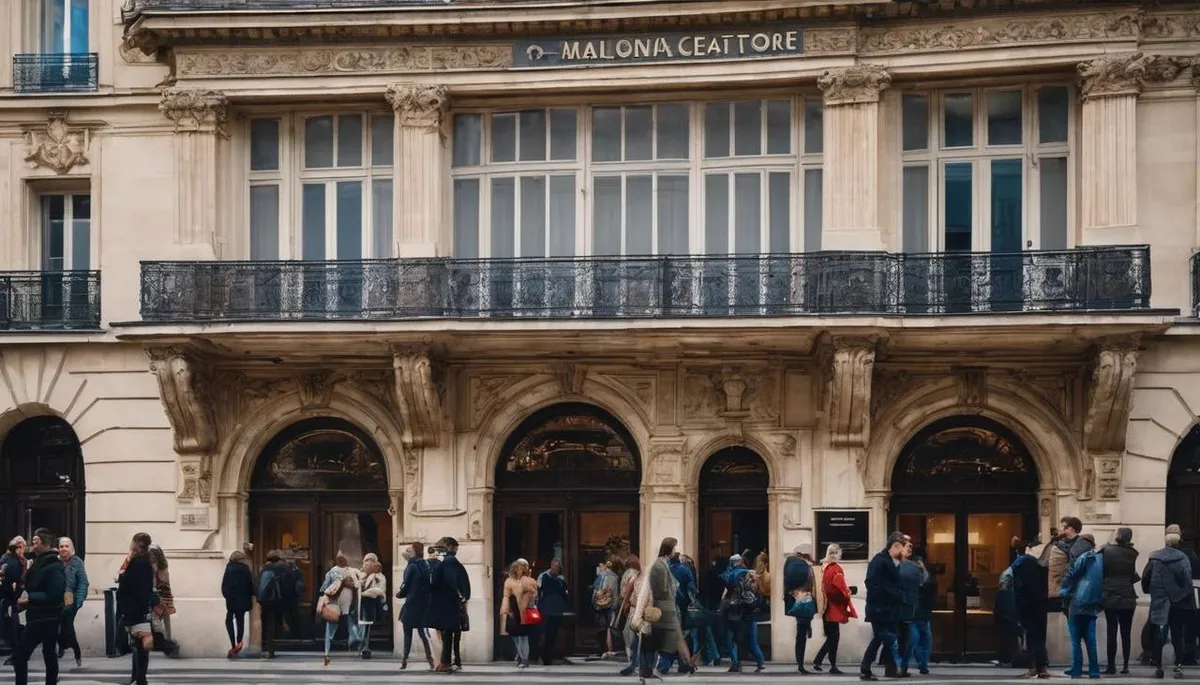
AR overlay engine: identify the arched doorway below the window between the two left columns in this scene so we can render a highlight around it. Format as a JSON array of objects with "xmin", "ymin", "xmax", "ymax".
[{"xmin": 250, "ymin": 417, "xmax": 395, "ymax": 649}]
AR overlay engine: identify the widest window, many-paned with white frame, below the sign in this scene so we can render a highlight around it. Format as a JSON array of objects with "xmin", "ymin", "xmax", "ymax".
[{"xmin": 452, "ymin": 98, "xmax": 822, "ymax": 258}]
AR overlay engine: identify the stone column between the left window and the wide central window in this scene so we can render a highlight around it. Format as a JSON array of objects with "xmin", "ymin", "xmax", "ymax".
[{"xmin": 388, "ymin": 83, "xmax": 450, "ymax": 257}]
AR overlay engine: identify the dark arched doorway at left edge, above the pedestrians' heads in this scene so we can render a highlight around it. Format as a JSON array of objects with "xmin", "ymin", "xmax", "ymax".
[{"xmin": 0, "ymin": 416, "xmax": 86, "ymax": 554}]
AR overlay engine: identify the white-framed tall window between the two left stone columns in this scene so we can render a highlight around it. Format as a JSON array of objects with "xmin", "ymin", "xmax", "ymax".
[{"xmin": 248, "ymin": 112, "xmax": 394, "ymax": 262}]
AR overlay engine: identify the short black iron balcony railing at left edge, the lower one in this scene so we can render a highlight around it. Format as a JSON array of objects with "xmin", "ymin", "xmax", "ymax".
[{"xmin": 0, "ymin": 271, "xmax": 100, "ymax": 331}]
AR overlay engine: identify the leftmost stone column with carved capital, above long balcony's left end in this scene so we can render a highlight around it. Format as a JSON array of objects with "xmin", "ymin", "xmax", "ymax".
[{"xmin": 158, "ymin": 88, "xmax": 229, "ymax": 259}]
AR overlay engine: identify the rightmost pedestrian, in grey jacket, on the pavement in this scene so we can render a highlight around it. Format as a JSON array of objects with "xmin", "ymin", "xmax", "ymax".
[{"xmin": 1141, "ymin": 524, "xmax": 1195, "ymax": 679}]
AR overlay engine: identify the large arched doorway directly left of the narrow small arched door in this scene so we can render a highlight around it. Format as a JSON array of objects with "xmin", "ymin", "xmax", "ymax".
[{"xmin": 493, "ymin": 403, "xmax": 642, "ymax": 659}]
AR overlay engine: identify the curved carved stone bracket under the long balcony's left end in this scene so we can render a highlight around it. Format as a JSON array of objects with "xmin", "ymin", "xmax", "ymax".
[{"xmin": 146, "ymin": 347, "xmax": 216, "ymax": 455}]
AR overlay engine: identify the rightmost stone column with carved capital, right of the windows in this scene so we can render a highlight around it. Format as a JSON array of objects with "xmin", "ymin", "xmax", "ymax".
[{"xmin": 1079, "ymin": 53, "xmax": 1186, "ymax": 245}]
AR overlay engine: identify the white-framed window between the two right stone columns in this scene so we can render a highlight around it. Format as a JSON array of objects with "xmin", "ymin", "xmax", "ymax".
[{"xmin": 901, "ymin": 84, "xmax": 1072, "ymax": 253}]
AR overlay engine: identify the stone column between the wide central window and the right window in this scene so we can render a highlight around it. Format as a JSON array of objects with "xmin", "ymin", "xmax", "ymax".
[{"xmin": 817, "ymin": 64, "xmax": 892, "ymax": 250}]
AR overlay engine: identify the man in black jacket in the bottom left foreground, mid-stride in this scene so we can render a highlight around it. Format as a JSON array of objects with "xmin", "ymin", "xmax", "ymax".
[{"xmin": 12, "ymin": 528, "xmax": 67, "ymax": 685}]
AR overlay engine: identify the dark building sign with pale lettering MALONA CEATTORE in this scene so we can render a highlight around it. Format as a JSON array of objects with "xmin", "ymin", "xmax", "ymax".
[{"xmin": 512, "ymin": 26, "xmax": 804, "ymax": 68}]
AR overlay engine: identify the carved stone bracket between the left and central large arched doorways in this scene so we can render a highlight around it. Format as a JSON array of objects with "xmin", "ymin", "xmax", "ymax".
[{"xmin": 392, "ymin": 345, "xmax": 444, "ymax": 451}]
